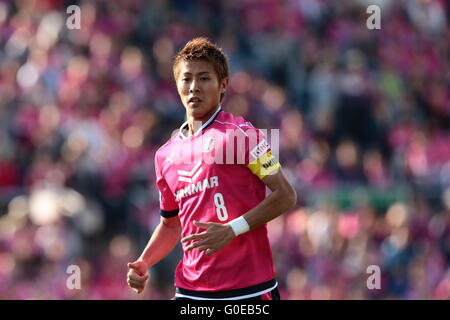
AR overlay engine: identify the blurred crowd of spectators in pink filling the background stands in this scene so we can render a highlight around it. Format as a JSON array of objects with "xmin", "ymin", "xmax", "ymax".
[{"xmin": 0, "ymin": 0, "xmax": 450, "ymax": 299}]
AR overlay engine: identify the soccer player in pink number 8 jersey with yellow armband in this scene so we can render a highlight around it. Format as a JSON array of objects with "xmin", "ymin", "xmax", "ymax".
[{"xmin": 128, "ymin": 38, "xmax": 297, "ymax": 300}]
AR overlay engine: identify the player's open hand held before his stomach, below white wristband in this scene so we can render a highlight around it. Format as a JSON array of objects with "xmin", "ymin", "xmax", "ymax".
[{"xmin": 181, "ymin": 221, "xmax": 235, "ymax": 256}]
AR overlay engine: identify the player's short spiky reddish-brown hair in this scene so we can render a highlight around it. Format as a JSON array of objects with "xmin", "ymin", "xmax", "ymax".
[{"xmin": 173, "ymin": 37, "xmax": 229, "ymax": 101}]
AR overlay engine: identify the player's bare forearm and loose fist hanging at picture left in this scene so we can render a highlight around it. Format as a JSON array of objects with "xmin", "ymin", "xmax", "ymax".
[{"xmin": 127, "ymin": 216, "xmax": 181, "ymax": 293}]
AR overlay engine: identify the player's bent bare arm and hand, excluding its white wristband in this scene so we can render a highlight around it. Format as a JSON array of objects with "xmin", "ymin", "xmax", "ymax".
[{"xmin": 181, "ymin": 168, "xmax": 297, "ymax": 255}]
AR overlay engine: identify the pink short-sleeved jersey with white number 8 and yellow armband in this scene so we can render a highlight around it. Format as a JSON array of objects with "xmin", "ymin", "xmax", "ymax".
[{"xmin": 155, "ymin": 107, "xmax": 280, "ymax": 298}]
